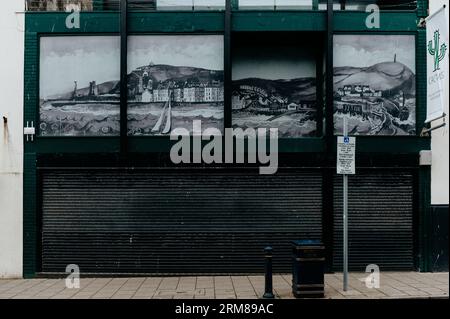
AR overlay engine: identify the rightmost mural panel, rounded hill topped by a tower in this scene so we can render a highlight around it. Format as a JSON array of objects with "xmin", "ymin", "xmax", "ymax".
[{"xmin": 334, "ymin": 35, "xmax": 416, "ymax": 135}]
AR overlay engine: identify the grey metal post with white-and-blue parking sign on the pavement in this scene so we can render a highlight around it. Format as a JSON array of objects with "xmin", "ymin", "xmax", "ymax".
[{"xmin": 336, "ymin": 117, "xmax": 356, "ymax": 291}]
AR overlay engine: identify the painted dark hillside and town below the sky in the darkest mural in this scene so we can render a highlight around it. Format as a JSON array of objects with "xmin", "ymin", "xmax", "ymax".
[{"xmin": 232, "ymin": 77, "xmax": 317, "ymax": 137}]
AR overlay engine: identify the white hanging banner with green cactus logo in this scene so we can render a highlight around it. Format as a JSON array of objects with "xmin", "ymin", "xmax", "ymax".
[{"xmin": 425, "ymin": 7, "xmax": 449, "ymax": 123}]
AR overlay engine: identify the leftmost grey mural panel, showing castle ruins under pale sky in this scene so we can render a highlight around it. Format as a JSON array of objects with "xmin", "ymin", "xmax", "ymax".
[{"xmin": 39, "ymin": 36, "xmax": 120, "ymax": 136}]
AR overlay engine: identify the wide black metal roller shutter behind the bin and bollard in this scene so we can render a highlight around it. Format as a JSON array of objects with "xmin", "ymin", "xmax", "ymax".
[{"xmin": 42, "ymin": 169, "xmax": 322, "ymax": 274}]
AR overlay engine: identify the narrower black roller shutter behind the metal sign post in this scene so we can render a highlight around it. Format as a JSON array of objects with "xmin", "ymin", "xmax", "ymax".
[{"xmin": 333, "ymin": 169, "xmax": 414, "ymax": 271}]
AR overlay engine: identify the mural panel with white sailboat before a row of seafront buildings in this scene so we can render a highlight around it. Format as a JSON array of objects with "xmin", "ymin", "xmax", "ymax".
[{"xmin": 128, "ymin": 35, "xmax": 224, "ymax": 135}]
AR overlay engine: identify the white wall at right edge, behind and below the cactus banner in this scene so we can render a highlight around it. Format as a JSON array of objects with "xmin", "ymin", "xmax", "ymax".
[{"xmin": 430, "ymin": 0, "xmax": 449, "ymax": 205}]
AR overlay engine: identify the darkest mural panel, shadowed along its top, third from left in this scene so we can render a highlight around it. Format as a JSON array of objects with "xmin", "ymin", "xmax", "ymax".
[{"xmin": 232, "ymin": 44, "xmax": 317, "ymax": 138}]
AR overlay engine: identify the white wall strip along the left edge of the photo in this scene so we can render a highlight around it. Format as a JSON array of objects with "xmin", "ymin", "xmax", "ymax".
[{"xmin": 0, "ymin": 0, "xmax": 24, "ymax": 278}]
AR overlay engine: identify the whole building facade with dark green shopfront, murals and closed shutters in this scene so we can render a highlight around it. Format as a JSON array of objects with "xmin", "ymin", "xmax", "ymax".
[{"xmin": 0, "ymin": 0, "xmax": 448, "ymax": 277}]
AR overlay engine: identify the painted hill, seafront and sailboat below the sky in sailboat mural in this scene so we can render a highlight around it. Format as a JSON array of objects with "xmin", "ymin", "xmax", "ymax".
[{"xmin": 128, "ymin": 63, "xmax": 224, "ymax": 135}]
